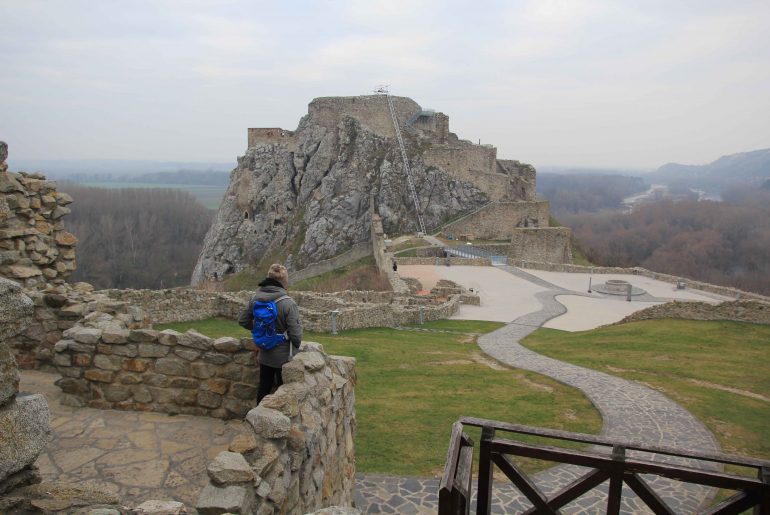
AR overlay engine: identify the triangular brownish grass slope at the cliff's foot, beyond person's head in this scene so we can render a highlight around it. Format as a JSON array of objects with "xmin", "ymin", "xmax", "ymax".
[{"xmin": 291, "ymin": 256, "xmax": 391, "ymax": 292}]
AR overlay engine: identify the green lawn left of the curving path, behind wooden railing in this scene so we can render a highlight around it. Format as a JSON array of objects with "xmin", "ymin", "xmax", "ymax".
[{"xmin": 156, "ymin": 320, "xmax": 601, "ymax": 476}]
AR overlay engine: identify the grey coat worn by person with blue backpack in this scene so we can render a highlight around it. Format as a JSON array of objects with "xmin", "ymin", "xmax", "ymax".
[{"xmin": 238, "ymin": 285, "xmax": 302, "ymax": 368}]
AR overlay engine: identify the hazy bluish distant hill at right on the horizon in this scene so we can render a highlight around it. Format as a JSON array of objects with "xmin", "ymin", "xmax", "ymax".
[{"xmin": 647, "ymin": 148, "xmax": 770, "ymax": 193}]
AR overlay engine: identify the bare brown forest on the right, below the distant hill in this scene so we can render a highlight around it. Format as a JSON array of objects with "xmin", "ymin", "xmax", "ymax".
[{"xmin": 560, "ymin": 186, "xmax": 770, "ymax": 294}]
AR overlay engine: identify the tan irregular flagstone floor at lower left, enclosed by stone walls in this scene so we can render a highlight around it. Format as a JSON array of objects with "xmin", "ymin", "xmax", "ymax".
[{"xmin": 21, "ymin": 370, "xmax": 246, "ymax": 508}]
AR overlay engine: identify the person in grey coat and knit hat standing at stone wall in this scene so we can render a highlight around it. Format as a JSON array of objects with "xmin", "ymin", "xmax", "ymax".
[{"xmin": 238, "ymin": 263, "xmax": 302, "ymax": 404}]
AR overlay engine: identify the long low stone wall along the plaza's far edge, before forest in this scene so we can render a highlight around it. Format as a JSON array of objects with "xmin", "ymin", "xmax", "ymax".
[{"xmin": 510, "ymin": 260, "xmax": 770, "ymax": 302}]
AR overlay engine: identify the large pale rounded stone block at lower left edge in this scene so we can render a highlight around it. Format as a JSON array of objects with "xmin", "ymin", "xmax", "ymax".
[{"xmin": 0, "ymin": 394, "xmax": 51, "ymax": 478}]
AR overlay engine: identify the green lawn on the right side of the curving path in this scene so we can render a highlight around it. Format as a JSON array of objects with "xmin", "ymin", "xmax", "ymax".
[{"xmin": 522, "ymin": 320, "xmax": 770, "ymax": 459}]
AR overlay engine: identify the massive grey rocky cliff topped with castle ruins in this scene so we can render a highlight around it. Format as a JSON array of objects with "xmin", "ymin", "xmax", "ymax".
[{"xmin": 192, "ymin": 95, "xmax": 534, "ymax": 285}]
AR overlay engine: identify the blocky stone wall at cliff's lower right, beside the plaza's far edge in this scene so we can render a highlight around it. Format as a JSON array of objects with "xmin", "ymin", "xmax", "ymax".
[{"xmin": 475, "ymin": 227, "xmax": 572, "ymax": 263}]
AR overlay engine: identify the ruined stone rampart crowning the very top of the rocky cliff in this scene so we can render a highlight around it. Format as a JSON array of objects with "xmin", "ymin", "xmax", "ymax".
[{"xmin": 308, "ymin": 95, "xmax": 422, "ymax": 138}]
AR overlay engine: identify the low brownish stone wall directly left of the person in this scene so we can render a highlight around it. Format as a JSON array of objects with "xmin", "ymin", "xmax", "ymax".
[{"xmin": 54, "ymin": 311, "xmax": 259, "ymax": 418}]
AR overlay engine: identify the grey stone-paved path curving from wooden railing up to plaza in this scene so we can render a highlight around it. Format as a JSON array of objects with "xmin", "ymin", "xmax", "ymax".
[{"xmin": 355, "ymin": 266, "xmax": 719, "ymax": 514}]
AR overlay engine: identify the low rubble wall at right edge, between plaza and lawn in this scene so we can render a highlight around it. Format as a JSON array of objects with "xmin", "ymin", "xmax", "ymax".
[{"xmin": 617, "ymin": 300, "xmax": 770, "ymax": 325}]
